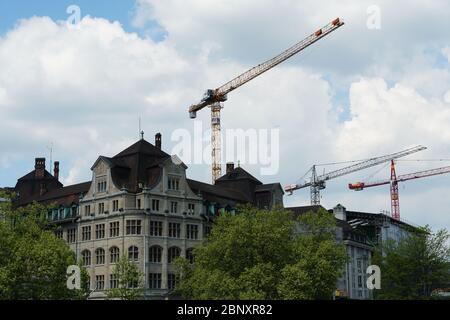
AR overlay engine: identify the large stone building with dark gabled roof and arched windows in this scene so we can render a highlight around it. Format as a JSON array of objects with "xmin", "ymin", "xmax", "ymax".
[{"xmin": 10, "ymin": 134, "xmax": 283, "ymax": 299}]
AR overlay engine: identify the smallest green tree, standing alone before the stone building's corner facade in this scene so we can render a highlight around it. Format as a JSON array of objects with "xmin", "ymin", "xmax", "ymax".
[{"xmin": 107, "ymin": 255, "xmax": 144, "ymax": 300}]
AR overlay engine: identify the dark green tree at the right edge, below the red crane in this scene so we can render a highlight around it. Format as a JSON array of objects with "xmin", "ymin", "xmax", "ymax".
[{"xmin": 373, "ymin": 226, "xmax": 450, "ymax": 299}]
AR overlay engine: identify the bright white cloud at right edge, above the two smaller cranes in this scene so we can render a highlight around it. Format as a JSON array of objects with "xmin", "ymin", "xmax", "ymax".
[{"xmin": 337, "ymin": 78, "xmax": 450, "ymax": 156}]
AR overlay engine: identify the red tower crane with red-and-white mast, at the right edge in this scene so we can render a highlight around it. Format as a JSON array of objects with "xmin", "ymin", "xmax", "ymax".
[{"xmin": 348, "ymin": 160, "xmax": 450, "ymax": 220}]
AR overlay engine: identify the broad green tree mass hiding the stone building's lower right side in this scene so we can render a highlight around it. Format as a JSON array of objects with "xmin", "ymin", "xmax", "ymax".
[{"xmin": 176, "ymin": 206, "xmax": 346, "ymax": 299}]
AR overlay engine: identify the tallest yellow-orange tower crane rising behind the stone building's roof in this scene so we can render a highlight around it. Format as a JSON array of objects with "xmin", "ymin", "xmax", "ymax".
[{"xmin": 189, "ymin": 18, "xmax": 344, "ymax": 183}]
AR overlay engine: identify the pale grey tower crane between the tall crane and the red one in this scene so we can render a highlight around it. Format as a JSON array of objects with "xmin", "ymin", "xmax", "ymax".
[{"xmin": 284, "ymin": 146, "xmax": 426, "ymax": 205}]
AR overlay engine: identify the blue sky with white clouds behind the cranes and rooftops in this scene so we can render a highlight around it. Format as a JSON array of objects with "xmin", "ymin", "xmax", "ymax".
[{"xmin": 0, "ymin": 0, "xmax": 450, "ymax": 229}]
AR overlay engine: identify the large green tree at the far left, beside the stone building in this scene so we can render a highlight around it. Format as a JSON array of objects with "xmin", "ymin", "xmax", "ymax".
[{"xmin": 0, "ymin": 195, "xmax": 86, "ymax": 300}]
